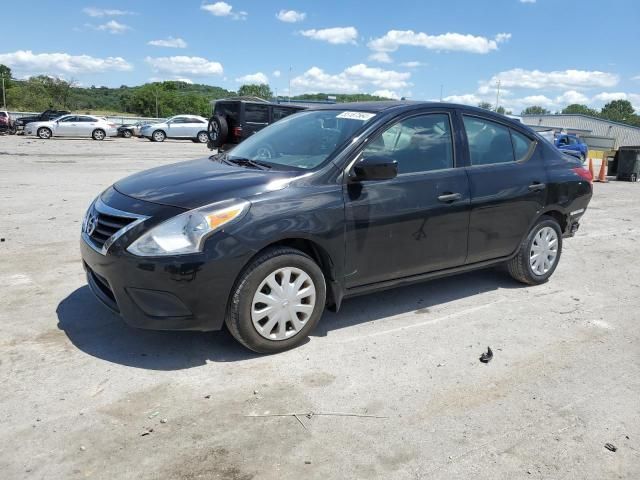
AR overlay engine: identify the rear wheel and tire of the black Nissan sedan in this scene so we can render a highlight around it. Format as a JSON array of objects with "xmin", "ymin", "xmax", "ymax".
[{"xmin": 507, "ymin": 215, "xmax": 562, "ymax": 285}]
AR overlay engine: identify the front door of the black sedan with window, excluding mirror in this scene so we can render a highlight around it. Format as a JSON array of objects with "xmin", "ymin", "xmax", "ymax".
[{"xmin": 344, "ymin": 111, "xmax": 470, "ymax": 288}]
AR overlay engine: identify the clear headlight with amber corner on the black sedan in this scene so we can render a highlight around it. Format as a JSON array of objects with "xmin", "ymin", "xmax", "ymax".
[{"xmin": 127, "ymin": 200, "xmax": 250, "ymax": 257}]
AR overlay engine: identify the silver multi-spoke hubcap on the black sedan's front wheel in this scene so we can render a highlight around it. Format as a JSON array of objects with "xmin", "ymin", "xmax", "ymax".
[{"xmin": 251, "ymin": 267, "xmax": 316, "ymax": 340}]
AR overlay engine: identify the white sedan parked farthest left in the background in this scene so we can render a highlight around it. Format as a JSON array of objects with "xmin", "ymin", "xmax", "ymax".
[{"xmin": 25, "ymin": 114, "xmax": 118, "ymax": 140}]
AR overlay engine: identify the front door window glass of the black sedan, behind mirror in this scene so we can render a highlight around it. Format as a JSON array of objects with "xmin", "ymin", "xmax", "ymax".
[{"xmin": 363, "ymin": 113, "xmax": 453, "ymax": 174}]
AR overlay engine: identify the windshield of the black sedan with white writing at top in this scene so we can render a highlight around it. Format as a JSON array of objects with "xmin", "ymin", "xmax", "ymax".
[{"xmin": 228, "ymin": 110, "xmax": 375, "ymax": 169}]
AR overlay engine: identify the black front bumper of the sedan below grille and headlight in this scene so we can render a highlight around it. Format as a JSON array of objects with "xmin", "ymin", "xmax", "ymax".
[{"xmin": 80, "ymin": 191, "xmax": 253, "ymax": 331}]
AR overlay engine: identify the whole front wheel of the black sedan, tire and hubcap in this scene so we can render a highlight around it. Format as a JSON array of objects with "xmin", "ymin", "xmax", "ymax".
[{"xmin": 225, "ymin": 247, "xmax": 326, "ymax": 353}]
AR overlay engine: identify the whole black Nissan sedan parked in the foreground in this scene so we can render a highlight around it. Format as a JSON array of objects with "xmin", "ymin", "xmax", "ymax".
[{"xmin": 81, "ymin": 102, "xmax": 592, "ymax": 353}]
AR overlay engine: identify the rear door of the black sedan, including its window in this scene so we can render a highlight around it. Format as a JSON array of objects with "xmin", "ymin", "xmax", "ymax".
[{"xmin": 462, "ymin": 112, "xmax": 547, "ymax": 263}]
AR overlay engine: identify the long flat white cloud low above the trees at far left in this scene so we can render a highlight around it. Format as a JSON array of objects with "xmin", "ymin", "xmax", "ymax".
[{"xmin": 0, "ymin": 50, "xmax": 133, "ymax": 75}]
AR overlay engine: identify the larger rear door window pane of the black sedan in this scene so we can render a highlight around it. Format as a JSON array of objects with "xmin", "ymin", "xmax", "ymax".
[{"xmin": 463, "ymin": 115, "xmax": 515, "ymax": 165}]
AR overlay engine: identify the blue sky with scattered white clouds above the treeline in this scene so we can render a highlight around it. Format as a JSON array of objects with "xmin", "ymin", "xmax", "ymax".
[{"xmin": 0, "ymin": 0, "xmax": 640, "ymax": 113}]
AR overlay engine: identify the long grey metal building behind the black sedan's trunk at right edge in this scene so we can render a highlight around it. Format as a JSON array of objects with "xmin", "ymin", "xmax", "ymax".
[{"xmin": 521, "ymin": 114, "xmax": 640, "ymax": 150}]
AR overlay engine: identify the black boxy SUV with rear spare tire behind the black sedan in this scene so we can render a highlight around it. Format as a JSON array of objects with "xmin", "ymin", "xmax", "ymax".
[{"xmin": 208, "ymin": 99, "xmax": 306, "ymax": 150}]
